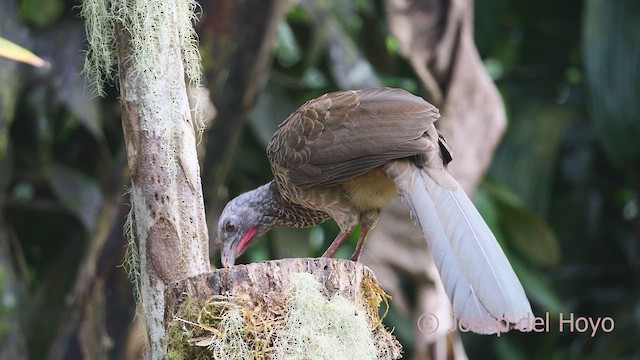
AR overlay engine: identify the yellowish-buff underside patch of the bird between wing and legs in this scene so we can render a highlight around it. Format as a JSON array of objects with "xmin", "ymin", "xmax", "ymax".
[{"xmin": 343, "ymin": 167, "xmax": 398, "ymax": 211}]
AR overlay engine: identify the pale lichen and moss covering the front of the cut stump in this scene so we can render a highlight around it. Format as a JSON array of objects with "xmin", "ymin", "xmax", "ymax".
[{"xmin": 167, "ymin": 273, "xmax": 390, "ymax": 360}]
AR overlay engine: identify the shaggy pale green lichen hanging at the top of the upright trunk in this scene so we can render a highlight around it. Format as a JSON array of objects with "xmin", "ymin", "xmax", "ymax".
[{"xmin": 80, "ymin": 0, "xmax": 204, "ymax": 134}]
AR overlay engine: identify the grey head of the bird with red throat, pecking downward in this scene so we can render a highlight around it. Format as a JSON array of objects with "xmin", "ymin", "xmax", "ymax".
[{"xmin": 218, "ymin": 185, "xmax": 273, "ymax": 267}]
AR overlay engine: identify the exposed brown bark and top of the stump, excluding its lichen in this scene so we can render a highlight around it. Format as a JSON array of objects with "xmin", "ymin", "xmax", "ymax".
[{"xmin": 165, "ymin": 258, "xmax": 401, "ymax": 359}]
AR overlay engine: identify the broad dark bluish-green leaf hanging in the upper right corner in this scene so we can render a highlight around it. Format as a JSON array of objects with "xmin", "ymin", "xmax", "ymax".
[{"xmin": 583, "ymin": 0, "xmax": 640, "ymax": 167}]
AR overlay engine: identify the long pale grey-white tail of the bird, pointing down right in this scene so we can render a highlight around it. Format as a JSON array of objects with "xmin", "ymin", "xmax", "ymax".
[{"xmin": 385, "ymin": 161, "xmax": 533, "ymax": 333}]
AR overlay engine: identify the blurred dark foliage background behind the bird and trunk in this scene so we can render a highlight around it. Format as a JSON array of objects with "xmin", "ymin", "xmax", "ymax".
[{"xmin": 0, "ymin": 0, "xmax": 640, "ymax": 359}]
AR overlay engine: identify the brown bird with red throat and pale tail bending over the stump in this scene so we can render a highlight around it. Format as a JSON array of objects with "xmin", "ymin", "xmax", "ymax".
[{"xmin": 217, "ymin": 88, "xmax": 532, "ymax": 326}]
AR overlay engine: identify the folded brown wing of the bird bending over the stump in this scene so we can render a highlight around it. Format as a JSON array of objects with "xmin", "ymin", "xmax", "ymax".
[{"xmin": 267, "ymin": 88, "xmax": 442, "ymax": 188}]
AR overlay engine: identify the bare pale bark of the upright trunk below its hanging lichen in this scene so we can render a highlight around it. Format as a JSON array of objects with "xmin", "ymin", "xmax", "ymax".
[{"xmin": 116, "ymin": 5, "xmax": 210, "ymax": 359}]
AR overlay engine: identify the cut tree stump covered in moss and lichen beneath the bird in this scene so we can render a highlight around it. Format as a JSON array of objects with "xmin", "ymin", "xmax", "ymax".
[{"xmin": 165, "ymin": 258, "xmax": 402, "ymax": 359}]
